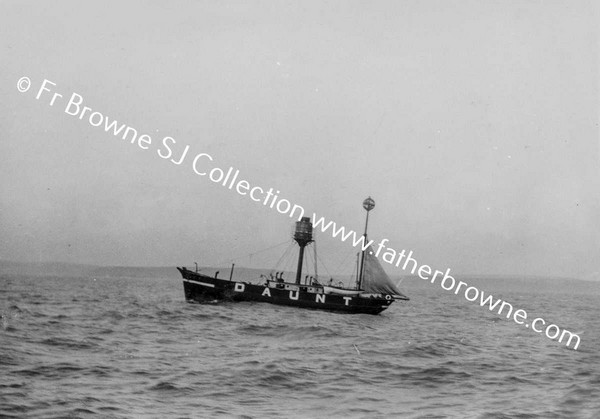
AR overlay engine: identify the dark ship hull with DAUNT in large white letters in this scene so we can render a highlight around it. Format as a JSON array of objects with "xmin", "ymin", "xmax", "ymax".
[{"xmin": 177, "ymin": 268, "xmax": 394, "ymax": 314}]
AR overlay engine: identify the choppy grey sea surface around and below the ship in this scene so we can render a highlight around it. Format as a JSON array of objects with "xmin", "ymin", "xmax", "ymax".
[{"xmin": 0, "ymin": 275, "xmax": 600, "ymax": 418}]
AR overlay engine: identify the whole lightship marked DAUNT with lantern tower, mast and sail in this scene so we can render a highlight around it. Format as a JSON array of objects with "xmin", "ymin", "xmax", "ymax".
[{"xmin": 177, "ymin": 197, "xmax": 409, "ymax": 314}]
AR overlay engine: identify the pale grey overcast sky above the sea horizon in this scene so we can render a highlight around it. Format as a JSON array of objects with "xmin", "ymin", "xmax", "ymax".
[{"xmin": 0, "ymin": 0, "xmax": 600, "ymax": 279}]
